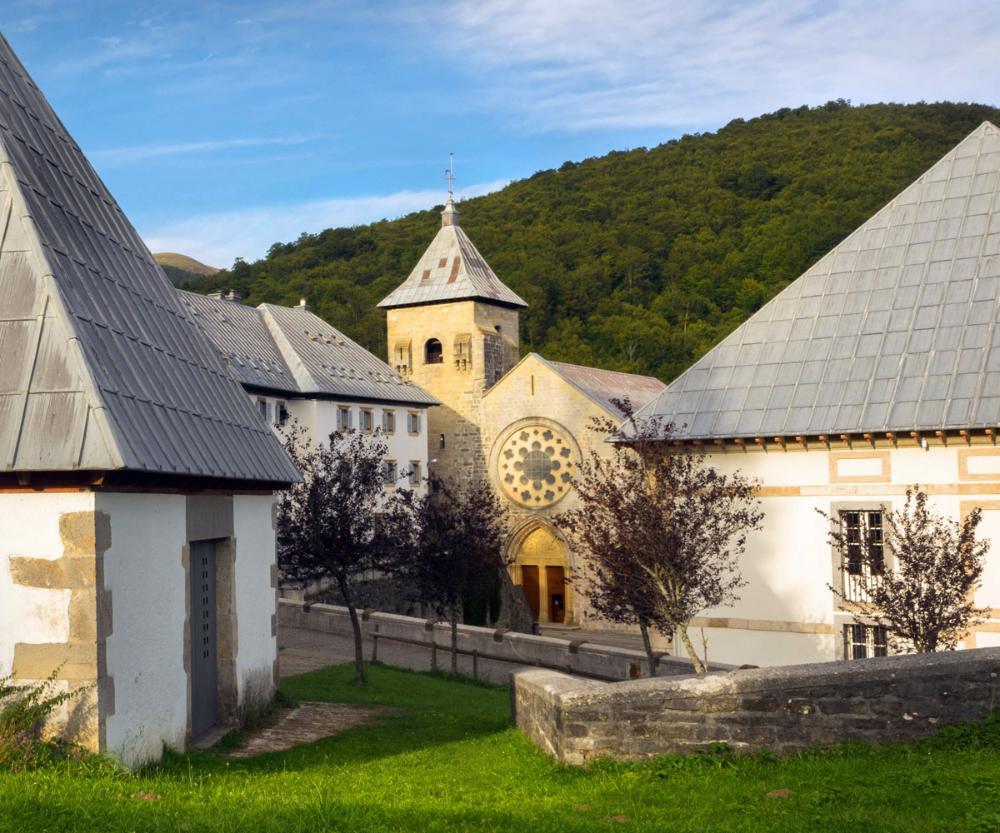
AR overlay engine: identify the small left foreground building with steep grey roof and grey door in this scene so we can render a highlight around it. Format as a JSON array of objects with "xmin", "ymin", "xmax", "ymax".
[{"xmin": 0, "ymin": 37, "xmax": 298, "ymax": 763}]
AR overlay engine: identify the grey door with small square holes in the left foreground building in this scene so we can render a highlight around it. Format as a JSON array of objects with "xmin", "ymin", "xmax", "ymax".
[{"xmin": 189, "ymin": 541, "xmax": 219, "ymax": 737}]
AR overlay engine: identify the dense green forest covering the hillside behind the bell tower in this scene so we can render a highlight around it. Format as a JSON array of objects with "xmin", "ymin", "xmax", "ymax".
[{"xmin": 189, "ymin": 101, "xmax": 1000, "ymax": 381}]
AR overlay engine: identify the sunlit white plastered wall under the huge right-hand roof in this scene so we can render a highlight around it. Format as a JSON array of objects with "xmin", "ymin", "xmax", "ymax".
[{"xmin": 676, "ymin": 443, "xmax": 1000, "ymax": 665}]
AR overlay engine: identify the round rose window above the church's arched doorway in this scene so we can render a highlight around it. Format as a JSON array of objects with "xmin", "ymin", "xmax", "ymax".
[{"xmin": 496, "ymin": 425, "xmax": 578, "ymax": 507}]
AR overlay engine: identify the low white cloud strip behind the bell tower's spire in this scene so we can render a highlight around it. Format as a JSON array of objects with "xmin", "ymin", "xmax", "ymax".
[{"xmin": 143, "ymin": 180, "xmax": 507, "ymax": 266}]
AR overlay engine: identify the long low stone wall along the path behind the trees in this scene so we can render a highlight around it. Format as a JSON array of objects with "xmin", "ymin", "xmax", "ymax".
[{"xmin": 278, "ymin": 599, "xmax": 732, "ymax": 681}]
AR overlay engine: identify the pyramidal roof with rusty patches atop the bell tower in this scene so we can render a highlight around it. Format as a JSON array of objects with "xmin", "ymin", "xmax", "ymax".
[{"xmin": 379, "ymin": 198, "xmax": 528, "ymax": 309}]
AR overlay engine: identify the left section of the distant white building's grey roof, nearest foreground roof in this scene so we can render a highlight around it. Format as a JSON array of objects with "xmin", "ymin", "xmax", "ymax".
[{"xmin": 177, "ymin": 289, "xmax": 300, "ymax": 394}]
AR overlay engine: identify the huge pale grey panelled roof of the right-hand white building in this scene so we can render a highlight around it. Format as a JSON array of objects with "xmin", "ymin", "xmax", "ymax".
[{"xmin": 642, "ymin": 122, "xmax": 1000, "ymax": 439}]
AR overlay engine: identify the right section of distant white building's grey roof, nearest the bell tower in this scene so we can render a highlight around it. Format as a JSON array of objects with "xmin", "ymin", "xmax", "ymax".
[{"xmin": 258, "ymin": 302, "xmax": 438, "ymax": 405}]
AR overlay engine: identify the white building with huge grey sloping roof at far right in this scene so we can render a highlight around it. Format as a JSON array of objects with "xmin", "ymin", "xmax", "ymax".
[{"xmin": 640, "ymin": 122, "xmax": 1000, "ymax": 664}]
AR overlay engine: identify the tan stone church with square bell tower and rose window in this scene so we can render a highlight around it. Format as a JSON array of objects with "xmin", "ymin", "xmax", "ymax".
[{"xmin": 379, "ymin": 197, "xmax": 664, "ymax": 627}]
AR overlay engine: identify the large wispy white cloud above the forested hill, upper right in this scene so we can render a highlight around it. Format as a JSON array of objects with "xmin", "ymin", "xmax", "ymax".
[{"xmin": 422, "ymin": 0, "xmax": 1000, "ymax": 130}]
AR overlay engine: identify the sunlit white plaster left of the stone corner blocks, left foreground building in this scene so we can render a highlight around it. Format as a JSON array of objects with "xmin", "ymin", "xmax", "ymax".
[{"xmin": 0, "ymin": 492, "xmax": 94, "ymax": 677}]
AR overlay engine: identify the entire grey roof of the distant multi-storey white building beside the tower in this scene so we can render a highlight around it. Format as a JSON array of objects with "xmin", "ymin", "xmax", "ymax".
[{"xmin": 177, "ymin": 289, "xmax": 437, "ymax": 406}]
